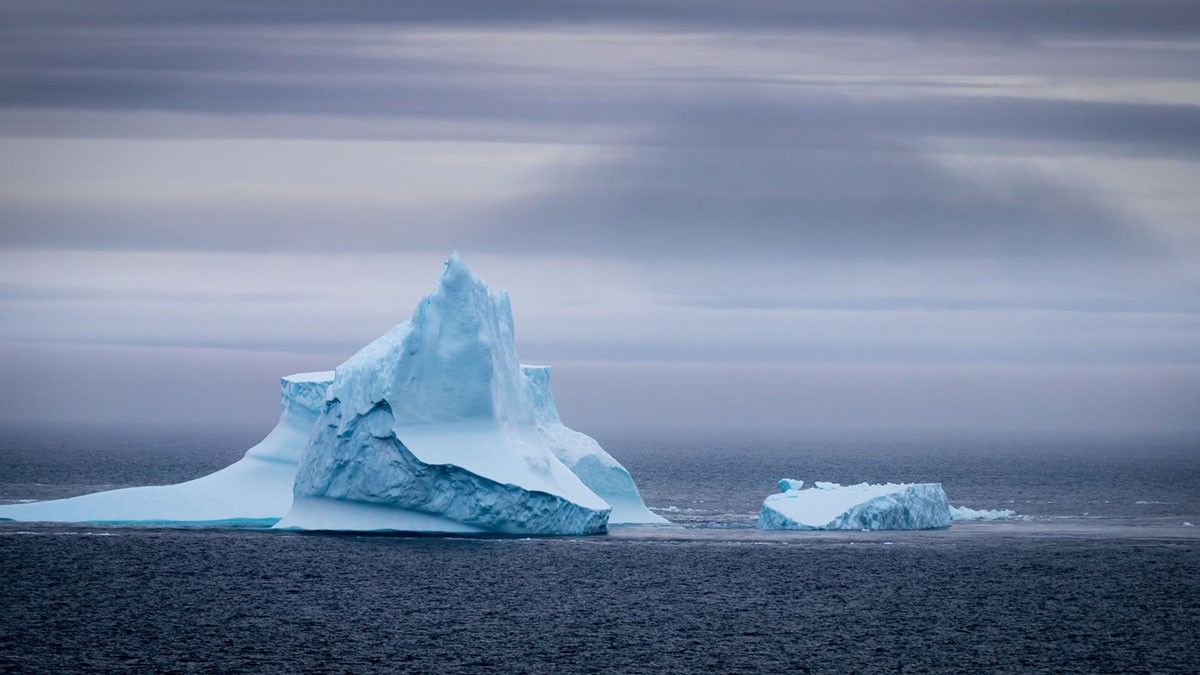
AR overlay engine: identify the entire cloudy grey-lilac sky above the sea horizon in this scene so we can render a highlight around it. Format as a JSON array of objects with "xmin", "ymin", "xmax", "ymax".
[{"xmin": 0, "ymin": 0, "xmax": 1200, "ymax": 431}]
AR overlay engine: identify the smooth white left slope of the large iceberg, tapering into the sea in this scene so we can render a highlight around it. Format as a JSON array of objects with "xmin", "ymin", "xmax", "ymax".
[{"xmin": 0, "ymin": 372, "xmax": 334, "ymax": 526}]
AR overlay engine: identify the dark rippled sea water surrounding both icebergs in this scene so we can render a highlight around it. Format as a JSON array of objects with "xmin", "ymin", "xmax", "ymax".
[{"xmin": 0, "ymin": 428, "xmax": 1200, "ymax": 673}]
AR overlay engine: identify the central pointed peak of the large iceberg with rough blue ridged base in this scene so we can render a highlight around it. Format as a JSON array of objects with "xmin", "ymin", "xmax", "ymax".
[{"xmin": 276, "ymin": 255, "xmax": 610, "ymax": 534}]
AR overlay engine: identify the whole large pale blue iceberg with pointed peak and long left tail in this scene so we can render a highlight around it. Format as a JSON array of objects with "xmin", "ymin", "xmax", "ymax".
[{"xmin": 0, "ymin": 255, "xmax": 666, "ymax": 533}]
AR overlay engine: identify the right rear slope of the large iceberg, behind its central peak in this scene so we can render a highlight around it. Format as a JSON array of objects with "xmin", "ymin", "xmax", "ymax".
[{"xmin": 521, "ymin": 365, "xmax": 667, "ymax": 525}]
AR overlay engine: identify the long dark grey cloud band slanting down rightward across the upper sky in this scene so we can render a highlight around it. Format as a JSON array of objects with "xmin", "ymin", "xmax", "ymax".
[{"xmin": 0, "ymin": 22, "xmax": 1200, "ymax": 155}]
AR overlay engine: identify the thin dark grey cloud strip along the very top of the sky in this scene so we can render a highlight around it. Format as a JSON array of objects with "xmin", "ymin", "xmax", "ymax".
[{"xmin": 5, "ymin": 0, "xmax": 1200, "ymax": 37}]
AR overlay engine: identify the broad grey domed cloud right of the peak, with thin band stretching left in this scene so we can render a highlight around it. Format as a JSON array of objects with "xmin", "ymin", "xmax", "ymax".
[{"xmin": 0, "ymin": 91, "xmax": 1180, "ymax": 258}]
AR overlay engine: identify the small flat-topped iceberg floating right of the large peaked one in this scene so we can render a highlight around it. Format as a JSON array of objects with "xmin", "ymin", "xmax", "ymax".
[{"xmin": 758, "ymin": 478, "xmax": 950, "ymax": 530}]
